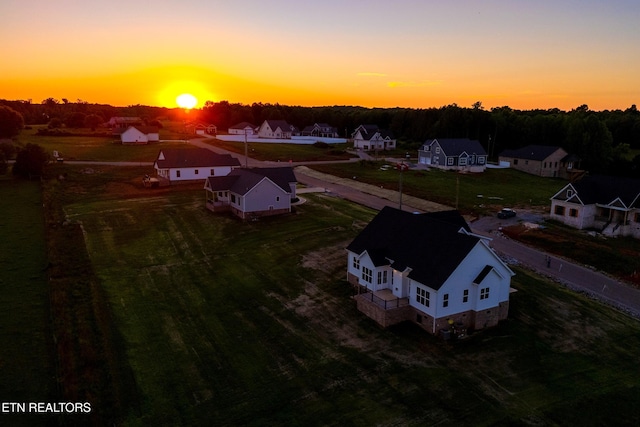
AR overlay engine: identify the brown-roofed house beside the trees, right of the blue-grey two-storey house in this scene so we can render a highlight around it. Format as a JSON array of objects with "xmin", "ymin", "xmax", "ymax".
[{"xmin": 498, "ymin": 145, "xmax": 583, "ymax": 179}]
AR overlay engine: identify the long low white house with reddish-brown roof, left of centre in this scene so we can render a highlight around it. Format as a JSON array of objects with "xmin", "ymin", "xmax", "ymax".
[{"xmin": 153, "ymin": 148, "xmax": 240, "ymax": 185}]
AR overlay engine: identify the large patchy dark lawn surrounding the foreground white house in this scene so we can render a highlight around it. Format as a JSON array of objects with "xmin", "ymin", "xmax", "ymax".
[{"xmin": 38, "ymin": 168, "xmax": 640, "ymax": 426}]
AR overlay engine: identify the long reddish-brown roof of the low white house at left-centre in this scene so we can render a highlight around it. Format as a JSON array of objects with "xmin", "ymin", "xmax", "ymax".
[{"xmin": 155, "ymin": 148, "xmax": 240, "ymax": 169}]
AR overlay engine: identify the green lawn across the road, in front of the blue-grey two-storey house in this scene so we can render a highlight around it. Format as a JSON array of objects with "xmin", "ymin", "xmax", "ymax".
[{"xmin": 310, "ymin": 161, "xmax": 566, "ymax": 215}]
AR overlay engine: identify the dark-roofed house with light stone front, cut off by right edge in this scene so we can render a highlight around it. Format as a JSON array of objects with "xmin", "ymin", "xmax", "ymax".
[{"xmin": 550, "ymin": 176, "xmax": 640, "ymax": 239}]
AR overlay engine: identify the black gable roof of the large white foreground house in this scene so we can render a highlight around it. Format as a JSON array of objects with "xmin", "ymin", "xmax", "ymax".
[{"xmin": 347, "ymin": 206, "xmax": 480, "ymax": 290}]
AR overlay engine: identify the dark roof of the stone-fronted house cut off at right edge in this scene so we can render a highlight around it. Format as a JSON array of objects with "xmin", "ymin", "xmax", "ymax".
[{"xmin": 572, "ymin": 175, "xmax": 640, "ymax": 208}]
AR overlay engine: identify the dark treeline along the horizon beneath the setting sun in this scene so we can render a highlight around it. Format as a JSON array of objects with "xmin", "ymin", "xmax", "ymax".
[{"xmin": 0, "ymin": 98, "xmax": 640, "ymax": 176}]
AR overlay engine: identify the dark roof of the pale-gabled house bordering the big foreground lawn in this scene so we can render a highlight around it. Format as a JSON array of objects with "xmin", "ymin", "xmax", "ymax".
[{"xmin": 206, "ymin": 167, "xmax": 296, "ymax": 195}]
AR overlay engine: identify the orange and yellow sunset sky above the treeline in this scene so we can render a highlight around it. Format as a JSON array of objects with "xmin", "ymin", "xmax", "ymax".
[{"xmin": 0, "ymin": 0, "xmax": 640, "ymax": 110}]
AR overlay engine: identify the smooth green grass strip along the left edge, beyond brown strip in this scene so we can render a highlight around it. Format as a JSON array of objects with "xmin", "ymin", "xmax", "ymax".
[{"xmin": 0, "ymin": 179, "xmax": 57, "ymax": 425}]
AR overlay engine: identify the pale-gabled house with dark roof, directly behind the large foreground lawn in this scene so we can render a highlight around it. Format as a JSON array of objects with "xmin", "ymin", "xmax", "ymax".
[{"xmin": 204, "ymin": 167, "xmax": 296, "ymax": 219}]
